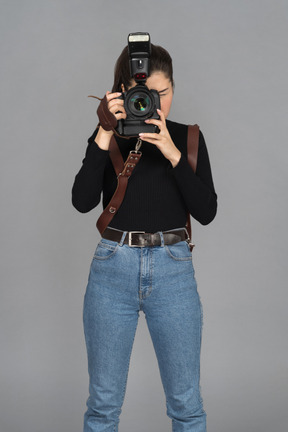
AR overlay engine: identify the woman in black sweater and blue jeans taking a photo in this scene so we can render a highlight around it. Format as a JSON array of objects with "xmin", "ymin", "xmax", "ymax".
[{"xmin": 72, "ymin": 40, "xmax": 217, "ymax": 432}]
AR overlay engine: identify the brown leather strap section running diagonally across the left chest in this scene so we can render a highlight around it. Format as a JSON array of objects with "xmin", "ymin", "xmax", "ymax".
[{"xmin": 96, "ymin": 135, "xmax": 142, "ymax": 234}]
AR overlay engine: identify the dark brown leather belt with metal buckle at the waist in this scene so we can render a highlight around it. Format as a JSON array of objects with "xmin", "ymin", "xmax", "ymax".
[{"xmin": 102, "ymin": 227, "xmax": 188, "ymax": 247}]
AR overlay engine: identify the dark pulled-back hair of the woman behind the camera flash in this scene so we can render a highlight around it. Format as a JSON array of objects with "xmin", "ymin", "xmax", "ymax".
[{"xmin": 112, "ymin": 43, "xmax": 174, "ymax": 93}]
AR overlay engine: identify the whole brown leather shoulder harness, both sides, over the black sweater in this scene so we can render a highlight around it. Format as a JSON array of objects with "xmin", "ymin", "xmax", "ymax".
[{"xmin": 96, "ymin": 125, "xmax": 199, "ymax": 240}]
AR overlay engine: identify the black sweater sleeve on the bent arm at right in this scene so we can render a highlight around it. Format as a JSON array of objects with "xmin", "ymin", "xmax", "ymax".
[{"xmin": 171, "ymin": 131, "xmax": 217, "ymax": 225}]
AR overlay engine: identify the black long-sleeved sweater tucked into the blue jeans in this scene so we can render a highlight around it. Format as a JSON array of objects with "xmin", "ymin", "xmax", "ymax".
[{"xmin": 72, "ymin": 120, "xmax": 217, "ymax": 233}]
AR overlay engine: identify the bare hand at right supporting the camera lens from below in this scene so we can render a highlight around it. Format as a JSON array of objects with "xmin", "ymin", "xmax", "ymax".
[{"xmin": 139, "ymin": 109, "xmax": 181, "ymax": 168}]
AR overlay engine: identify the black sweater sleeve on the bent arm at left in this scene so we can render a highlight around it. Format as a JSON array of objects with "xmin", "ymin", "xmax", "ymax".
[{"xmin": 72, "ymin": 130, "xmax": 109, "ymax": 213}]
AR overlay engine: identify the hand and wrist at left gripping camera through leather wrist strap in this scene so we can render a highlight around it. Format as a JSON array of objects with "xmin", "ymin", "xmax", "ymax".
[{"xmin": 94, "ymin": 91, "xmax": 127, "ymax": 150}]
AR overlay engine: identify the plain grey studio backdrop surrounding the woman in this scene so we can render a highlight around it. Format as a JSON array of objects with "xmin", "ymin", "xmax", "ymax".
[{"xmin": 0, "ymin": 0, "xmax": 288, "ymax": 432}]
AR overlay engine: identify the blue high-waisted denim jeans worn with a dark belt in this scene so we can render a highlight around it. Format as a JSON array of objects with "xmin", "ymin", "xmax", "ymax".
[{"xmin": 83, "ymin": 228, "xmax": 206, "ymax": 432}]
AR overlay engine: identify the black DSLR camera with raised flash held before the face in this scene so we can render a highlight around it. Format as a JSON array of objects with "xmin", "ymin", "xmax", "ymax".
[{"xmin": 116, "ymin": 33, "xmax": 160, "ymax": 136}]
